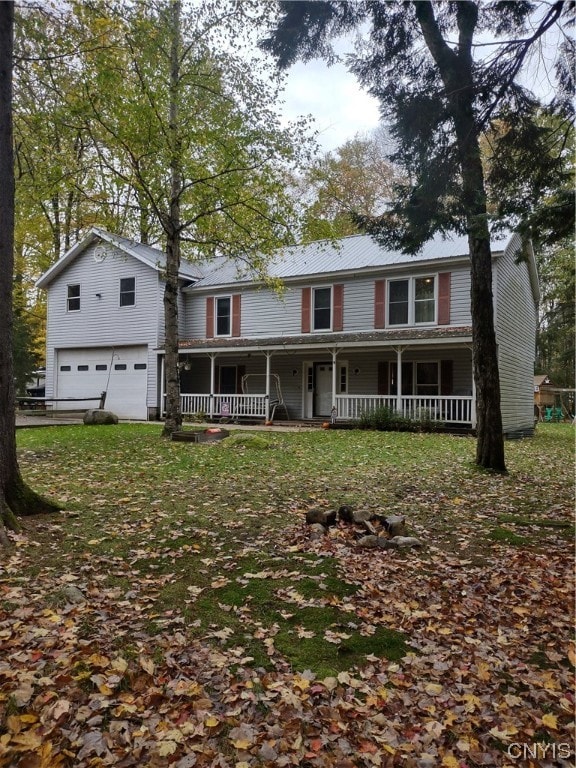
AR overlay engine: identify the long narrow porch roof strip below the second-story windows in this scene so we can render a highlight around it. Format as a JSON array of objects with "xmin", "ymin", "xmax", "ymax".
[{"xmin": 172, "ymin": 326, "xmax": 472, "ymax": 354}]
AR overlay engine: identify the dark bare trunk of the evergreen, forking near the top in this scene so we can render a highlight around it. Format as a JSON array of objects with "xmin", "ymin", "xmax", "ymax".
[{"xmin": 415, "ymin": 0, "xmax": 506, "ymax": 472}]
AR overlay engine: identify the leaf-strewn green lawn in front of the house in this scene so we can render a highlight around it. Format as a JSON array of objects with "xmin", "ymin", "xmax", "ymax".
[{"xmin": 0, "ymin": 424, "xmax": 574, "ymax": 768}]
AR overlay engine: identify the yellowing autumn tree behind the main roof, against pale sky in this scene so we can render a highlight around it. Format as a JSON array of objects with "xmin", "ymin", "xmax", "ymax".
[{"xmin": 297, "ymin": 129, "xmax": 398, "ymax": 240}]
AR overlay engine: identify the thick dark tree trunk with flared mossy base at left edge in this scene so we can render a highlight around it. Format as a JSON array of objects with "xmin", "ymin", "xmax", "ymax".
[{"xmin": 0, "ymin": 2, "xmax": 57, "ymax": 545}]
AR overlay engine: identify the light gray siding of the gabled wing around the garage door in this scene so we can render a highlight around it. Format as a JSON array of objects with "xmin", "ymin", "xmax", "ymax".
[{"xmin": 46, "ymin": 244, "xmax": 158, "ymax": 418}]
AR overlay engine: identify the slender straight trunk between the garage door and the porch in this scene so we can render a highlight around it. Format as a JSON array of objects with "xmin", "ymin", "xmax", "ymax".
[{"xmin": 162, "ymin": 0, "xmax": 182, "ymax": 437}]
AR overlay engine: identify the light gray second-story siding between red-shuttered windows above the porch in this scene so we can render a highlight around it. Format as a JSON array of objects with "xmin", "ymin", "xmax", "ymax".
[{"xmin": 182, "ymin": 265, "xmax": 471, "ymax": 338}]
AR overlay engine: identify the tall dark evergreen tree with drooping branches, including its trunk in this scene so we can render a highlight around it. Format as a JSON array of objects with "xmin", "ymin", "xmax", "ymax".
[{"xmin": 261, "ymin": 0, "xmax": 572, "ymax": 472}]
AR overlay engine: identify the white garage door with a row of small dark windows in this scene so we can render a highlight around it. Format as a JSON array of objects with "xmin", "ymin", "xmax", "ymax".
[{"xmin": 54, "ymin": 347, "xmax": 148, "ymax": 419}]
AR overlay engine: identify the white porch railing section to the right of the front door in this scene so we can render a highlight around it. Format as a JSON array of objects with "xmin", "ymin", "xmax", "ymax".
[{"xmin": 336, "ymin": 395, "xmax": 472, "ymax": 424}]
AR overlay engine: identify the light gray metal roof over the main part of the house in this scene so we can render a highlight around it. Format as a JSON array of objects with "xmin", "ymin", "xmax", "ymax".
[{"xmin": 194, "ymin": 233, "xmax": 511, "ymax": 288}]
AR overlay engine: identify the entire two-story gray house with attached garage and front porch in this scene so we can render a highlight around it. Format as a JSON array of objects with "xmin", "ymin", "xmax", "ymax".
[{"xmin": 38, "ymin": 229, "xmax": 538, "ymax": 435}]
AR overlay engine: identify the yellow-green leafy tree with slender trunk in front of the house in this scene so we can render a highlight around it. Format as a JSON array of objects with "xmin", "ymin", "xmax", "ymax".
[{"xmin": 18, "ymin": 0, "xmax": 306, "ymax": 435}]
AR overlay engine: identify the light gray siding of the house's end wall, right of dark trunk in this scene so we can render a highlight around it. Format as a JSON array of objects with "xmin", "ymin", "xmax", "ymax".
[{"xmin": 494, "ymin": 238, "xmax": 537, "ymax": 436}]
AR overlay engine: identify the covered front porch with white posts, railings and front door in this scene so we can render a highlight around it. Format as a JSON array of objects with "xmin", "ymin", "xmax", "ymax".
[{"xmin": 161, "ymin": 334, "xmax": 476, "ymax": 429}]
